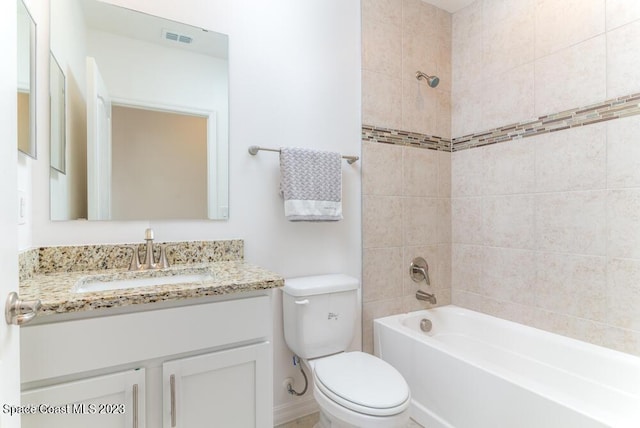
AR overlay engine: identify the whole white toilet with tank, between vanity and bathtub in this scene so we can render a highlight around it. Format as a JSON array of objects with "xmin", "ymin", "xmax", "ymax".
[{"xmin": 283, "ymin": 274, "xmax": 411, "ymax": 428}]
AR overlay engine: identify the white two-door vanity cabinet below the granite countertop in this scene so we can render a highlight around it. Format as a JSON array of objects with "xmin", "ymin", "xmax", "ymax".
[{"xmin": 21, "ymin": 295, "xmax": 273, "ymax": 428}]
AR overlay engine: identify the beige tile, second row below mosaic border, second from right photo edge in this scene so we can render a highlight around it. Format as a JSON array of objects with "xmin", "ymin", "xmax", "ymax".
[{"xmin": 535, "ymin": 190, "xmax": 607, "ymax": 256}]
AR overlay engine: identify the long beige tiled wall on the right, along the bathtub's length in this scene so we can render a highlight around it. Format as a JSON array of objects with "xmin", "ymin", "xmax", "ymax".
[{"xmin": 451, "ymin": 0, "xmax": 640, "ymax": 355}]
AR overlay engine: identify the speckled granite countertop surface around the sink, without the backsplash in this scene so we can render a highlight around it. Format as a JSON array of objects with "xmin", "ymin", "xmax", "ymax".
[{"xmin": 20, "ymin": 260, "xmax": 284, "ymax": 317}]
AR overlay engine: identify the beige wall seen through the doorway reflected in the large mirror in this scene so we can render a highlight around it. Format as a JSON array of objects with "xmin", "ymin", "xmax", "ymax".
[{"xmin": 112, "ymin": 106, "xmax": 207, "ymax": 220}]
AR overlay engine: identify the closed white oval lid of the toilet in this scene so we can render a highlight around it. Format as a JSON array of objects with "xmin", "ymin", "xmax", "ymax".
[{"xmin": 314, "ymin": 352, "xmax": 410, "ymax": 415}]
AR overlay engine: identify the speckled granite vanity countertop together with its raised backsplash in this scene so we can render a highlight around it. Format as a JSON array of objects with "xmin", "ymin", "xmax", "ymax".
[{"xmin": 20, "ymin": 241, "xmax": 284, "ymax": 318}]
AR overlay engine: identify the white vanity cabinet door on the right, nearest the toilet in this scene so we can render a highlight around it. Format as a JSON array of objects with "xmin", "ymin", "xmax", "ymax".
[{"xmin": 162, "ymin": 342, "xmax": 273, "ymax": 428}]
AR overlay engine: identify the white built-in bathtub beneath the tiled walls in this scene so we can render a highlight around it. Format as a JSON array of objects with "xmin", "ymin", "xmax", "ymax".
[{"xmin": 373, "ymin": 305, "xmax": 640, "ymax": 428}]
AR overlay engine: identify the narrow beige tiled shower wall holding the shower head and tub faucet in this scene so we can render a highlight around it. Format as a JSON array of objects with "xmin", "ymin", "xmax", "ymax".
[{"xmin": 362, "ymin": 0, "xmax": 451, "ymax": 352}]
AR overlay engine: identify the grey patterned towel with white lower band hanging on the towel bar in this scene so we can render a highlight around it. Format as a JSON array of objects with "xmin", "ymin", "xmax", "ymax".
[{"xmin": 280, "ymin": 147, "xmax": 342, "ymax": 221}]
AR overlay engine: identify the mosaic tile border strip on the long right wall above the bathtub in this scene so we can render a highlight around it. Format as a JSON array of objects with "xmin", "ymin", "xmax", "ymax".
[{"xmin": 451, "ymin": 93, "xmax": 640, "ymax": 152}]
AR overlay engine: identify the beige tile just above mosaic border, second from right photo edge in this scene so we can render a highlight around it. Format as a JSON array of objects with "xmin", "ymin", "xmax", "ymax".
[{"xmin": 535, "ymin": 35, "xmax": 607, "ymax": 117}]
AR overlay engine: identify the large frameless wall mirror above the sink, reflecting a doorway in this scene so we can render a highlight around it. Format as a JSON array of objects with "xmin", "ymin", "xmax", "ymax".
[{"xmin": 50, "ymin": 0, "xmax": 229, "ymax": 220}]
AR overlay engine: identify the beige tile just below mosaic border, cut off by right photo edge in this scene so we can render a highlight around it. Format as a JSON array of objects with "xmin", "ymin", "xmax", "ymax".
[{"xmin": 607, "ymin": 115, "xmax": 640, "ymax": 189}]
